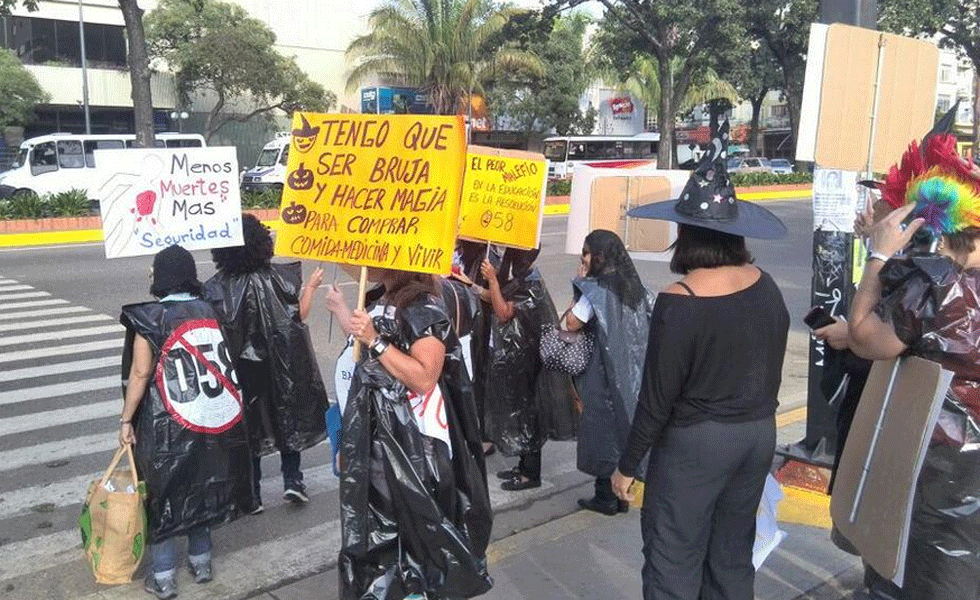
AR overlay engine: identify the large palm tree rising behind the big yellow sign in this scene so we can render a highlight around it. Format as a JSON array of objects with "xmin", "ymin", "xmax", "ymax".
[{"xmin": 347, "ymin": 0, "xmax": 542, "ymax": 115}]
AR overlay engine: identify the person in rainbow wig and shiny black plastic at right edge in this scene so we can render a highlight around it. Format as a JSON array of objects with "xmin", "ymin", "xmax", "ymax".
[{"xmin": 848, "ymin": 135, "xmax": 980, "ymax": 600}]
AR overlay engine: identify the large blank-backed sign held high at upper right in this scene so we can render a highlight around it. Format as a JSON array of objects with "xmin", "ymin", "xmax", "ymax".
[{"xmin": 796, "ymin": 23, "xmax": 939, "ymax": 173}]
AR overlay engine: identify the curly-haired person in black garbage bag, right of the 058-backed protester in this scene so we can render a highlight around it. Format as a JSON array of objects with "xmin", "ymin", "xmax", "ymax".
[{"xmin": 206, "ymin": 214, "xmax": 327, "ymax": 512}]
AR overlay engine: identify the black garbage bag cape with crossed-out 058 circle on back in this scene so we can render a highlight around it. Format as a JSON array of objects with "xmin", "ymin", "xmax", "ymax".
[{"xmin": 120, "ymin": 299, "xmax": 256, "ymax": 542}]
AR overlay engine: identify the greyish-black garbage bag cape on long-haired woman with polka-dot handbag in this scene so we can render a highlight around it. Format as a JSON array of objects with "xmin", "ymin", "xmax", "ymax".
[{"xmin": 572, "ymin": 278, "xmax": 654, "ymax": 477}]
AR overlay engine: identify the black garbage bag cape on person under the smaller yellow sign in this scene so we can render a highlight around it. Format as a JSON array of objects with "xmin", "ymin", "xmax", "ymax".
[{"xmin": 486, "ymin": 269, "xmax": 578, "ymax": 456}]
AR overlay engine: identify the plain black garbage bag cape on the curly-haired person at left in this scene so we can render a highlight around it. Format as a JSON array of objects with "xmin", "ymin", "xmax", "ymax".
[{"xmin": 205, "ymin": 262, "xmax": 327, "ymax": 455}]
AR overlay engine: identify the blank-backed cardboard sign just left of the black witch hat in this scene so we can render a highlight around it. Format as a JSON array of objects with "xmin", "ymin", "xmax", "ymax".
[{"xmin": 565, "ymin": 161, "xmax": 691, "ymax": 261}]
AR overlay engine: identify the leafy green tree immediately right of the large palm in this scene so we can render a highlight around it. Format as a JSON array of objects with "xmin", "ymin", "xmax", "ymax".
[{"xmin": 486, "ymin": 14, "xmax": 595, "ymax": 135}]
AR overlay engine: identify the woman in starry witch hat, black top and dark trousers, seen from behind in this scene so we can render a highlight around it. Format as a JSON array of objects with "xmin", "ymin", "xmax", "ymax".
[{"xmin": 612, "ymin": 115, "xmax": 789, "ymax": 600}]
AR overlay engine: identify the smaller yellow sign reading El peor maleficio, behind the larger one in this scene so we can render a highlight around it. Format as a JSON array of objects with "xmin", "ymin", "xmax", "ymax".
[{"xmin": 459, "ymin": 146, "xmax": 548, "ymax": 248}]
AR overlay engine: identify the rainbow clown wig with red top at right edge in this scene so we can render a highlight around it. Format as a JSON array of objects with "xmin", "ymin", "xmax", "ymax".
[{"xmin": 881, "ymin": 135, "xmax": 980, "ymax": 236}]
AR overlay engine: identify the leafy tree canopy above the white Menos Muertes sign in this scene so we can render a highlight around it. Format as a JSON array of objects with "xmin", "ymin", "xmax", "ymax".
[{"xmin": 146, "ymin": 0, "xmax": 337, "ymax": 140}]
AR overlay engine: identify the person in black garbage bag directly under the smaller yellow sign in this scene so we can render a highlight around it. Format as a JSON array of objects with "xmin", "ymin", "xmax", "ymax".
[{"xmin": 482, "ymin": 248, "xmax": 572, "ymax": 491}]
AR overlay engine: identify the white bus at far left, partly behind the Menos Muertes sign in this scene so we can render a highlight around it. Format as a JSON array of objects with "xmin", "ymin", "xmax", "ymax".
[{"xmin": 0, "ymin": 133, "xmax": 205, "ymax": 200}]
